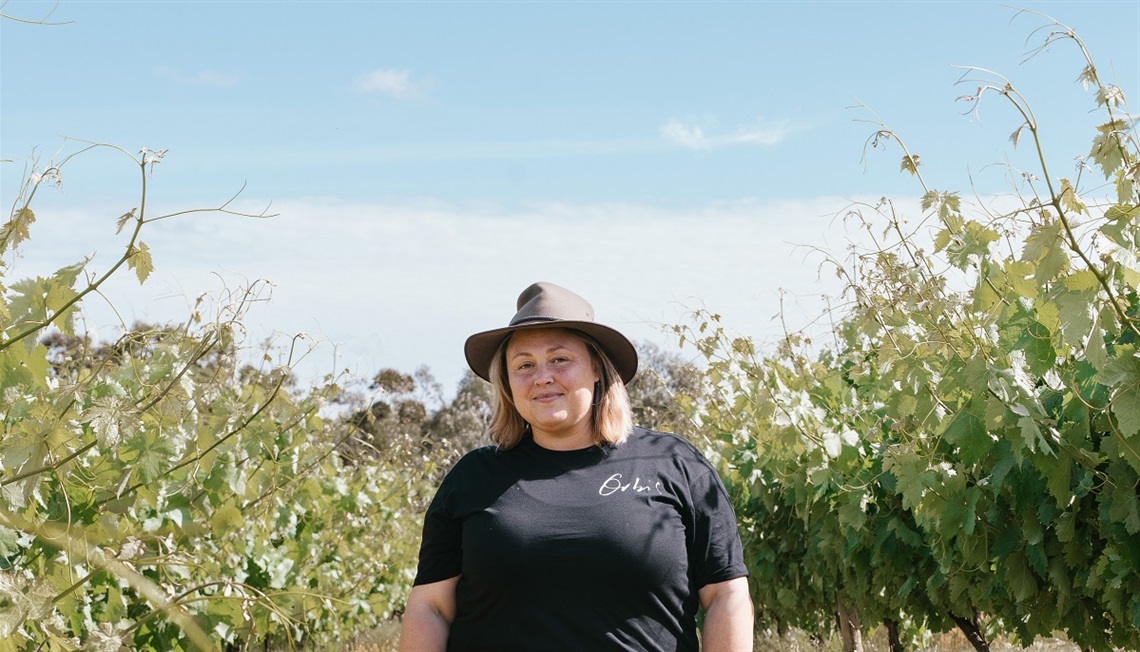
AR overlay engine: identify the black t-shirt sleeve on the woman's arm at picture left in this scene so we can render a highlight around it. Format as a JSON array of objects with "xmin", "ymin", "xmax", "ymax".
[{"xmin": 413, "ymin": 464, "xmax": 463, "ymax": 585}]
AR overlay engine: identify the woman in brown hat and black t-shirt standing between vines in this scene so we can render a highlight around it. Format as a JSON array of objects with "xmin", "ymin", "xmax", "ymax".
[{"xmin": 400, "ymin": 283, "xmax": 752, "ymax": 652}]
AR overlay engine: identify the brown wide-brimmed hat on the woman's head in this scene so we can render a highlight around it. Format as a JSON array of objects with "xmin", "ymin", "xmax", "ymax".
[{"xmin": 463, "ymin": 283, "xmax": 637, "ymax": 383}]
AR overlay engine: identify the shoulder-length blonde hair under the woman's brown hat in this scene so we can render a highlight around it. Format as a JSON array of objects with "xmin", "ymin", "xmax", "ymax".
[{"xmin": 487, "ymin": 326, "xmax": 634, "ymax": 450}]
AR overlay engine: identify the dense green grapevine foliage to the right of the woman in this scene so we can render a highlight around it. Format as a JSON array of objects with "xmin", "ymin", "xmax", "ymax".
[{"xmin": 677, "ymin": 16, "xmax": 1140, "ymax": 650}]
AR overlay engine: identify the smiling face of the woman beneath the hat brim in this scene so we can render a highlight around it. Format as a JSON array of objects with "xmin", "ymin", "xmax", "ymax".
[{"xmin": 506, "ymin": 328, "xmax": 600, "ymax": 450}]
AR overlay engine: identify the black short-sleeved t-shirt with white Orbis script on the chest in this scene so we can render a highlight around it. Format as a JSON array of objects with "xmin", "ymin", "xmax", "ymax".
[{"xmin": 415, "ymin": 429, "xmax": 748, "ymax": 652}]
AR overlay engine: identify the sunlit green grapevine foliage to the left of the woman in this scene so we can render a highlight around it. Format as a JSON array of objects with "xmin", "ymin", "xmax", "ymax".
[{"xmin": 0, "ymin": 146, "xmax": 467, "ymax": 650}]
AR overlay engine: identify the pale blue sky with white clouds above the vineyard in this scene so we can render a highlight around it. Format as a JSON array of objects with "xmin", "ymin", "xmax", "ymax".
[{"xmin": 0, "ymin": 0, "xmax": 1140, "ymax": 391}]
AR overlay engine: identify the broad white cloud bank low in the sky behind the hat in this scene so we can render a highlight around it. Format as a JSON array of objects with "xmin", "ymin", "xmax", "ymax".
[{"xmin": 19, "ymin": 197, "xmax": 889, "ymax": 390}]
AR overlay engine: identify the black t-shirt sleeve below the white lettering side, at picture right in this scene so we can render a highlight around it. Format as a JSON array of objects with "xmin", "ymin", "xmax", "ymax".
[{"xmin": 689, "ymin": 457, "xmax": 748, "ymax": 588}]
